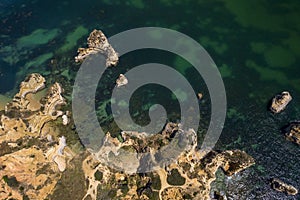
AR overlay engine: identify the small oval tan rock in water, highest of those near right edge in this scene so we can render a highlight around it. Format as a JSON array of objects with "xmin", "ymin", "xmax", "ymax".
[{"xmin": 270, "ymin": 91, "xmax": 292, "ymax": 113}]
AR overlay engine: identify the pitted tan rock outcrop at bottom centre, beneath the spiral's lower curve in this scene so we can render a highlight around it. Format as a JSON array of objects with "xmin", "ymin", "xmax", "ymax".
[{"xmin": 83, "ymin": 123, "xmax": 254, "ymax": 199}]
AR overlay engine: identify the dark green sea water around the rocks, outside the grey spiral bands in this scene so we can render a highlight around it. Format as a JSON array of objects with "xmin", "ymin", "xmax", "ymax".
[{"xmin": 0, "ymin": 0, "xmax": 300, "ymax": 199}]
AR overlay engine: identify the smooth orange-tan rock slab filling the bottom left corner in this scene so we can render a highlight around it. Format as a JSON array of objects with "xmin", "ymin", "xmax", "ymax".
[{"xmin": 0, "ymin": 147, "xmax": 59, "ymax": 199}]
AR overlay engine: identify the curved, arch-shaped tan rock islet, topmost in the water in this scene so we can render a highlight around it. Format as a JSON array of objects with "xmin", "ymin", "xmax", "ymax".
[{"xmin": 75, "ymin": 29, "xmax": 119, "ymax": 67}]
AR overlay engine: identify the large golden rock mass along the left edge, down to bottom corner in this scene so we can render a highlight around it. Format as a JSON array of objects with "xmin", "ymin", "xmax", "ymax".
[{"xmin": 0, "ymin": 74, "xmax": 74, "ymax": 199}]
